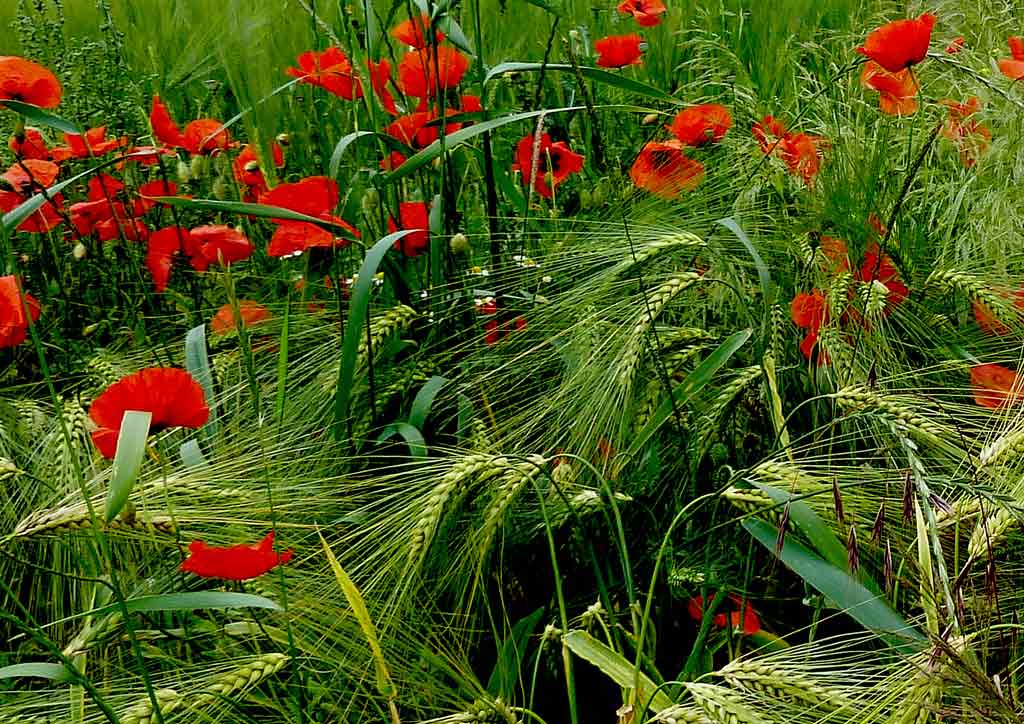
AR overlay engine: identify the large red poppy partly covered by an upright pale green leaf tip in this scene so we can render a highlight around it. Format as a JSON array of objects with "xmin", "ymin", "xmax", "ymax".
[{"xmin": 89, "ymin": 367, "xmax": 210, "ymax": 458}]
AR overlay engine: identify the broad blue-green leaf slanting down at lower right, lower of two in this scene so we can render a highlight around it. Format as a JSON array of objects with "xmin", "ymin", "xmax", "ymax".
[{"xmin": 743, "ymin": 518, "xmax": 926, "ymax": 650}]
